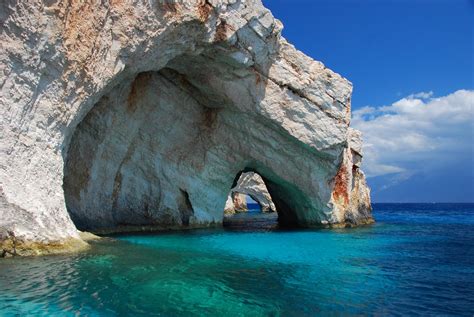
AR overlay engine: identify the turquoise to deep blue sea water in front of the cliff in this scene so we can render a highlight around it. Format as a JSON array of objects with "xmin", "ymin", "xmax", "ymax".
[{"xmin": 0, "ymin": 204, "xmax": 474, "ymax": 316}]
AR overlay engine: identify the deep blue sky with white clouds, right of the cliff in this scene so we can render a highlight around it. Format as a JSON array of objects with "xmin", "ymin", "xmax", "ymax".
[{"xmin": 263, "ymin": 0, "xmax": 474, "ymax": 202}]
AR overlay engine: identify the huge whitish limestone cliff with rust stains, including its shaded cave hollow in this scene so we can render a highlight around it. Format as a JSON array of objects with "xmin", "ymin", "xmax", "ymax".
[{"xmin": 0, "ymin": 0, "xmax": 372, "ymax": 254}]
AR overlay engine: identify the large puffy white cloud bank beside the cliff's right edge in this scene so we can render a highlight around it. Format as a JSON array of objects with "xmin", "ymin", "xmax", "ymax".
[{"xmin": 352, "ymin": 90, "xmax": 474, "ymax": 179}]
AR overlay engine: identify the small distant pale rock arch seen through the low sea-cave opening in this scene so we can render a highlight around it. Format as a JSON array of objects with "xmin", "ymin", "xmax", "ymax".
[{"xmin": 224, "ymin": 172, "xmax": 276, "ymax": 214}]
